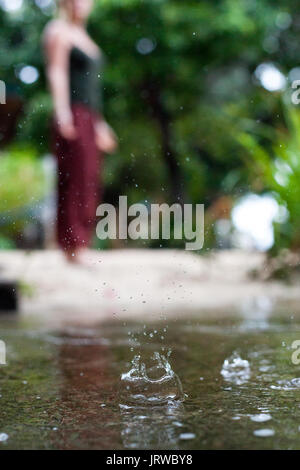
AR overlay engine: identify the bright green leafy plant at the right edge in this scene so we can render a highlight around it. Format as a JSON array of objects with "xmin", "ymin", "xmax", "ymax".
[{"xmin": 238, "ymin": 101, "xmax": 300, "ymax": 252}]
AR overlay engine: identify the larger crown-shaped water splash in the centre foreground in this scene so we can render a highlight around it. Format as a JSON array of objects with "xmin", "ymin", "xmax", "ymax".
[{"xmin": 120, "ymin": 351, "xmax": 184, "ymax": 405}]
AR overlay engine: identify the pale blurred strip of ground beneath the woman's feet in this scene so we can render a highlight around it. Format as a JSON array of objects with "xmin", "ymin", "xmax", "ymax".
[{"xmin": 0, "ymin": 249, "xmax": 300, "ymax": 323}]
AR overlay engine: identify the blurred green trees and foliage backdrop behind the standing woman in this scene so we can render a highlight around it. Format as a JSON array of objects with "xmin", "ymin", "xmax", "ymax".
[{"xmin": 0, "ymin": 0, "xmax": 300, "ymax": 262}]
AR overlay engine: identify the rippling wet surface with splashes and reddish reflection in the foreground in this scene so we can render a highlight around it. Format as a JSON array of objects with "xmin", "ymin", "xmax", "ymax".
[{"xmin": 0, "ymin": 309, "xmax": 300, "ymax": 449}]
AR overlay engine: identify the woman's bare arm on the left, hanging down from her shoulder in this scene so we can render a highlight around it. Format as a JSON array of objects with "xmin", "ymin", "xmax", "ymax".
[{"xmin": 44, "ymin": 22, "xmax": 76, "ymax": 139}]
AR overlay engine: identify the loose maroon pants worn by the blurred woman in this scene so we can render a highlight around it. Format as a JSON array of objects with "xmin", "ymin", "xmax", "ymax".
[{"xmin": 54, "ymin": 104, "xmax": 102, "ymax": 250}]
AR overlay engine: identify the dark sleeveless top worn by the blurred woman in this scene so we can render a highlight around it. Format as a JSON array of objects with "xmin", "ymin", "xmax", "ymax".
[{"xmin": 70, "ymin": 47, "xmax": 102, "ymax": 111}]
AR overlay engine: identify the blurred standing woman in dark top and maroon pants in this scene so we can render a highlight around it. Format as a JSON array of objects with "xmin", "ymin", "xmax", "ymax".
[{"xmin": 44, "ymin": 0, "xmax": 116, "ymax": 262}]
